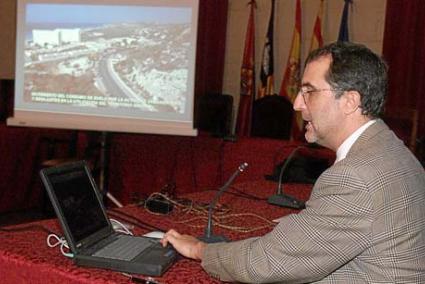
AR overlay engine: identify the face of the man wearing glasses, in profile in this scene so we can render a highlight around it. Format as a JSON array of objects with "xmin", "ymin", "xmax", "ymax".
[{"xmin": 294, "ymin": 55, "xmax": 344, "ymax": 150}]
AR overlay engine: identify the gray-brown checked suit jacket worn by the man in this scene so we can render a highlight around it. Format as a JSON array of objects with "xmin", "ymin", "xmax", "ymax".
[{"xmin": 202, "ymin": 120, "xmax": 425, "ymax": 283}]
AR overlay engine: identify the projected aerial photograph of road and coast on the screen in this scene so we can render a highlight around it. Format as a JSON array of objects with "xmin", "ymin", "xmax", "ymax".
[{"xmin": 24, "ymin": 4, "xmax": 193, "ymax": 113}]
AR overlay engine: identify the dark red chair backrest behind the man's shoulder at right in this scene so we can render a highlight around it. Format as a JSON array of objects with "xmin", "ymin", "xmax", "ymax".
[{"xmin": 382, "ymin": 107, "xmax": 418, "ymax": 153}]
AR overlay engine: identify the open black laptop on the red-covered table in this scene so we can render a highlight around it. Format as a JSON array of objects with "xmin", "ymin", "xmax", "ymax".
[{"xmin": 40, "ymin": 161, "xmax": 177, "ymax": 276}]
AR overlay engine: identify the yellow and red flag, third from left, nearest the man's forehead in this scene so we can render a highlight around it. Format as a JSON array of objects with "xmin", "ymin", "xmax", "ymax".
[{"xmin": 279, "ymin": 0, "xmax": 304, "ymax": 140}]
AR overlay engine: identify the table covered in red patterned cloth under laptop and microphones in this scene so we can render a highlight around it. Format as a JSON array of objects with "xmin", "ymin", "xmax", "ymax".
[{"xmin": 0, "ymin": 180, "xmax": 311, "ymax": 283}]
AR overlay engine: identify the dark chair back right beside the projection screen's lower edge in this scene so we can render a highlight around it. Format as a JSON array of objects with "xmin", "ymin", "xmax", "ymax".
[{"xmin": 195, "ymin": 93, "xmax": 233, "ymax": 137}]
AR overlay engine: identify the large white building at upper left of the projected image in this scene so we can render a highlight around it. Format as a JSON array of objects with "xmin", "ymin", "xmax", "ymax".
[{"xmin": 32, "ymin": 29, "xmax": 81, "ymax": 46}]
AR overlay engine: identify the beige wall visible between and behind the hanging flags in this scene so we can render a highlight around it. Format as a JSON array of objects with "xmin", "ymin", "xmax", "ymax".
[{"xmin": 223, "ymin": 0, "xmax": 386, "ymax": 130}]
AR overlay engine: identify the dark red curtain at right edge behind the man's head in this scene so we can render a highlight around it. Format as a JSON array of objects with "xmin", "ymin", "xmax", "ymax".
[{"xmin": 383, "ymin": 0, "xmax": 425, "ymax": 138}]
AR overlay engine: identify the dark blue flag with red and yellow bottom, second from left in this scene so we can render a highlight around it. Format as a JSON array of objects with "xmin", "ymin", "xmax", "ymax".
[{"xmin": 258, "ymin": 0, "xmax": 275, "ymax": 98}]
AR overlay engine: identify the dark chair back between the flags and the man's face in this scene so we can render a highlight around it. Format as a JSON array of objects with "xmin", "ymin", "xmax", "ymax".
[{"xmin": 251, "ymin": 95, "xmax": 294, "ymax": 139}]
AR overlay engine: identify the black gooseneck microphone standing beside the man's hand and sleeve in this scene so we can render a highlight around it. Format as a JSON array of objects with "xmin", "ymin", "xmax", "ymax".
[{"xmin": 198, "ymin": 162, "xmax": 248, "ymax": 243}]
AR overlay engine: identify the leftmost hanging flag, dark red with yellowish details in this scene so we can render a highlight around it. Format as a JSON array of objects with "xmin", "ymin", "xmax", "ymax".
[{"xmin": 236, "ymin": 0, "xmax": 256, "ymax": 136}]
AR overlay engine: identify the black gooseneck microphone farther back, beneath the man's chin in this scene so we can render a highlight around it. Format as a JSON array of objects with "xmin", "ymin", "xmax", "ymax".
[{"xmin": 267, "ymin": 146, "xmax": 305, "ymax": 209}]
